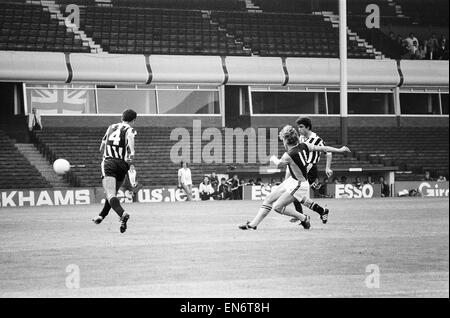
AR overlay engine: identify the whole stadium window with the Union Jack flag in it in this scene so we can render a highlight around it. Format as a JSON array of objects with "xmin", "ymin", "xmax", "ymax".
[{"xmin": 26, "ymin": 85, "xmax": 96, "ymax": 114}]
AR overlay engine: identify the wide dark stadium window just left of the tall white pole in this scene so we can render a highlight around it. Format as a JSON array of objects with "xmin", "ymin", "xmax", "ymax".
[{"xmin": 252, "ymin": 91, "xmax": 326, "ymax": 114}]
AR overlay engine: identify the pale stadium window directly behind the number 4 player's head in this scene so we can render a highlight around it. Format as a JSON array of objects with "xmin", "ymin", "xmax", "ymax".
[{"xmin": 97, "ymin": 89, "xmax": 156, "ymax": 114}]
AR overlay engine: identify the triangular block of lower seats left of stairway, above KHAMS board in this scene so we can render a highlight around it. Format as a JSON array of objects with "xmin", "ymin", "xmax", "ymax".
[{"xmin": 0, "ymin": 130, "xmax": 52, "ymax": 189}]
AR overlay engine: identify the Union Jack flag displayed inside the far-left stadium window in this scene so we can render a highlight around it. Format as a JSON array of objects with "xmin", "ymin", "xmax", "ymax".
[{"xmin": 31, "ymin": 88, "xmax": 89, "ymax": 114}]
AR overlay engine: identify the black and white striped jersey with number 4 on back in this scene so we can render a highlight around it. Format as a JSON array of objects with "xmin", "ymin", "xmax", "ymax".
[{"xmin": 102, "ymin": 123, "xmax": 137, "ymax": 160}]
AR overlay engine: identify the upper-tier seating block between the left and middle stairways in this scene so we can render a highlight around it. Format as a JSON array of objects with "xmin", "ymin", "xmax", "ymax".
[{"xmin": 81, "ymin": 7, "xmax": 249, "ymax": 55}]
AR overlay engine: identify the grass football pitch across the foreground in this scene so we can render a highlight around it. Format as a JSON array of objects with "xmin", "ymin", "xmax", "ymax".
[{"xmin": 0, "ymin": 198, "xmax": 449, "ymax": 298}]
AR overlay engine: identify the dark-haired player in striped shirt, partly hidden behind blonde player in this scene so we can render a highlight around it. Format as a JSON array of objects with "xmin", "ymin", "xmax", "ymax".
[{"xmin": 291, "ymin": 117, "xmax": 333, "ymax": 224}]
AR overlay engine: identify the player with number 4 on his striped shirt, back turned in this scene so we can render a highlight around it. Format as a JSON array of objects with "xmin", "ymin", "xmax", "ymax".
[{"xmin": 92, "ymin": 109, "xmax": 137, "ymax": 233}]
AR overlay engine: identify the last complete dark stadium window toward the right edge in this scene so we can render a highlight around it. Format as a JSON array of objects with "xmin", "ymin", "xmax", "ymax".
[{"xmin": 400, "ymin": 93, "xmax": 441, "ymax": 115}]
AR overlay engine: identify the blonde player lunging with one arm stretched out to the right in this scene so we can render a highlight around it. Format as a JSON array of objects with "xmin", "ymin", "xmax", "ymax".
[{"xmin": 239, "ymin": 125, "xmax": 350, "ymax": 230}]
